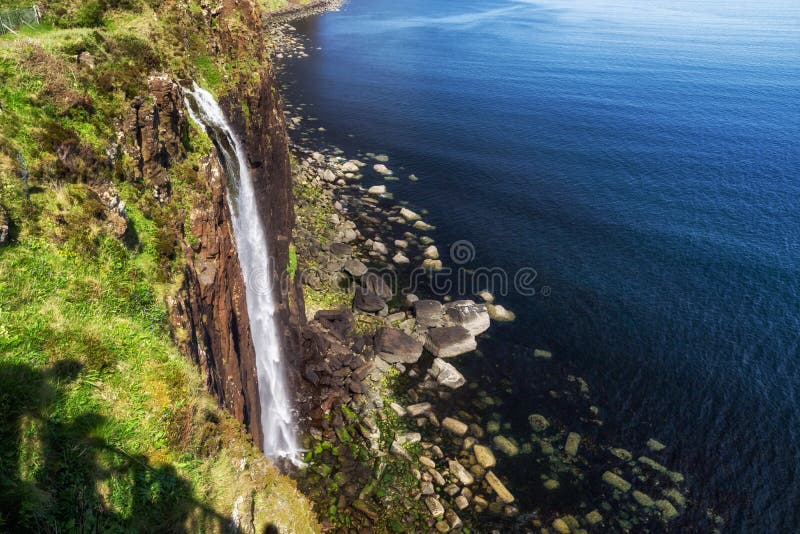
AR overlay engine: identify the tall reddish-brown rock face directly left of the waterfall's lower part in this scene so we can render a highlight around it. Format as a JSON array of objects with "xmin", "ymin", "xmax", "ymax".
[{"xmin": 172, "ymin": 157, "xmax": 263, "ymax": 444}]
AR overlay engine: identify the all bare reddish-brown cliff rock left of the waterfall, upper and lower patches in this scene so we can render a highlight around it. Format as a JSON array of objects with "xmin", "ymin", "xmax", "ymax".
[{"xmin": 124, "ymin": 75, "xmax": 262, "ymax": 444}]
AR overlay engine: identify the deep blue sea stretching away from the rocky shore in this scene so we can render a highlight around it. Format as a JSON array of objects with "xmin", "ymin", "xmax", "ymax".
[{"xmin": 287, "ymin": 0, "xmax": 800, "ymax": 532}]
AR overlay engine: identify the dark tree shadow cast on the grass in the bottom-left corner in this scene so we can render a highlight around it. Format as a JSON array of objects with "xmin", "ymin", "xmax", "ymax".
[{"xmin": 0, "ymin": 360, "xmax": 238, "ymax": 532}]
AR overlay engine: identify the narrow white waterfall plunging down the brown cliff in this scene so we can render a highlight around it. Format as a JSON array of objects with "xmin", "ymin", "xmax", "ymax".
[{"xmin": 185, "ymin": 84, "xmax": 300, "ymax": 463}]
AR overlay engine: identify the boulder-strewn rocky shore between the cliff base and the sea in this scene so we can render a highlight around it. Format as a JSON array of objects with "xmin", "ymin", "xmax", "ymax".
[{"xmin": 268, "ymin": 16, "xmax": 720, "ymax": 533}]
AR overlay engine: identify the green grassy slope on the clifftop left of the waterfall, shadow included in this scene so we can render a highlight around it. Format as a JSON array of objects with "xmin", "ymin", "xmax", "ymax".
[{"xmin": 0, "ymin": 2, "xmax": 316, "ymax": 532}]
